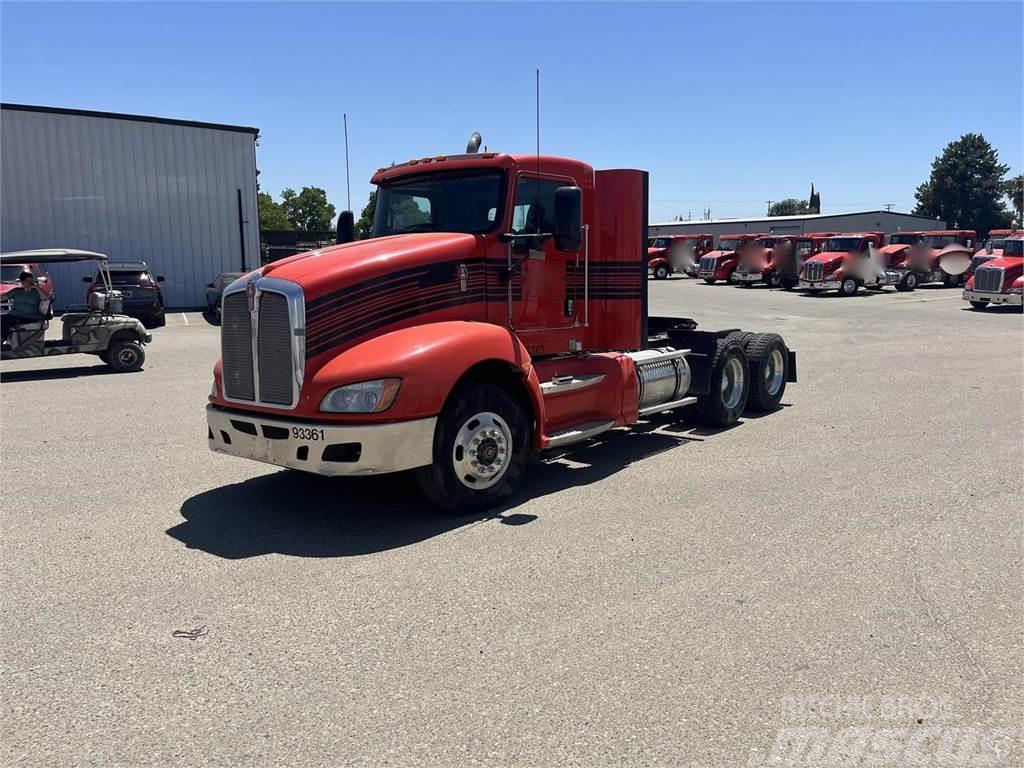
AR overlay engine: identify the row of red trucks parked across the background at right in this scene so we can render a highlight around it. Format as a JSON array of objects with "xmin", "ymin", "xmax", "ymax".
[{"xmin": 648, "ymin": 229, "xmax": 1016, "ymax": 306}]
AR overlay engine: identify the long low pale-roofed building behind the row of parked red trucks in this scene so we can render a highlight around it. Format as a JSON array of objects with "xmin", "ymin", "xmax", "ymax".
[{"xmin": 649, "ymin": 211, "xmax": 946, "ymax": 242}]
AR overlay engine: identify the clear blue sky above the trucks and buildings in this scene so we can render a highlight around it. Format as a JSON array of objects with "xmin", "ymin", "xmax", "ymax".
[{"xmin": 0, "ymin": 2, "xmax": 1024, "ymax": 221}]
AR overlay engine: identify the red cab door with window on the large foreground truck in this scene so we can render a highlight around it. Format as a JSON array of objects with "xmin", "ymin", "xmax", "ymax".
[{"xmin": 487, "ymin": 173, "xmax": 583, "ymax": 342}]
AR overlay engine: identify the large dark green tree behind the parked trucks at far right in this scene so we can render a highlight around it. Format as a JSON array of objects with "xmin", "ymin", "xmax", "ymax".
[{"xmin": 913, "ymin": 133, "xmax": 1010, "ymax": 232}]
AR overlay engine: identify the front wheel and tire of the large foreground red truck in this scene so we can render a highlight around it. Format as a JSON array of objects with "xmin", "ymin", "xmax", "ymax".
[{"xmin": 415, "ymin": 384, "xmax": 530, "ymax": 513}]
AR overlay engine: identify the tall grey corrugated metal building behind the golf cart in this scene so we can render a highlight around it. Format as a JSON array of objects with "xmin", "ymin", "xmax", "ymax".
[{"xmin": 0, "ymin": 104, "xmax": 259, "ymax": 309}]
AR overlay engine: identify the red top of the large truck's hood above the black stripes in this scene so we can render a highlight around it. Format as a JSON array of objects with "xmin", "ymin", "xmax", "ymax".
[{"xmin": 261, "ymin": 232, "xmax": 483, "ymax": 303}]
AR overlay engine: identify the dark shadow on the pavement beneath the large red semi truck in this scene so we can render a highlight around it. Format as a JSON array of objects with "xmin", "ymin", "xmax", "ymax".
[{"xmin": 167, "ymin": 414, "xmax": 753, "ymax": 559}]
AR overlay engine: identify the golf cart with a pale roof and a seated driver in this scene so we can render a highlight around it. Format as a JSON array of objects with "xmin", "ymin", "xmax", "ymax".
[{"xmin": 0, "ymin": 248, "xmax": 153, "ymax": 373}]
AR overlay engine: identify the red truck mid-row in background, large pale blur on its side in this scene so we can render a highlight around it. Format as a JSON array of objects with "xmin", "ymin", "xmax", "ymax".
[{"xmin": 800, "ymin": 232, "xmax": 913, "ymax": 296}]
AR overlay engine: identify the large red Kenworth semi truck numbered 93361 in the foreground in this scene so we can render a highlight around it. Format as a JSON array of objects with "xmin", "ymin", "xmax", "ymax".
[{"xmin": 207, "ymin": 148, "xmax": 796, "ymax": 511}]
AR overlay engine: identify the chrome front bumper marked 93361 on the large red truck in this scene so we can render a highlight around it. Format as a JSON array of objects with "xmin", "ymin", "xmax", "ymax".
[{"xmin": 206, "ymin": 404, "xmax": 437, "ymax": 475}]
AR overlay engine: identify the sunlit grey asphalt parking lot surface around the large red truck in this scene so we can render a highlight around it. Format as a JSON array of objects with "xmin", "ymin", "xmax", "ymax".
[{"xmin": 0, "ymin": 279, "xmax": 1024, "ymax": 766}]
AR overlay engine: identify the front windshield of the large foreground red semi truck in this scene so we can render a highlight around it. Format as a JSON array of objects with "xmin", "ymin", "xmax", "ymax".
[{"xmin": 373, "ymin": 169, "xmax": 505, "ymax": 238}]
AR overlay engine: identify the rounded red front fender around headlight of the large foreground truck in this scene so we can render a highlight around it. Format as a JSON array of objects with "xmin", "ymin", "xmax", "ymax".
[{"xmin": 301, "ymin": 321, "xmax": 544, "ymax": 439}]
